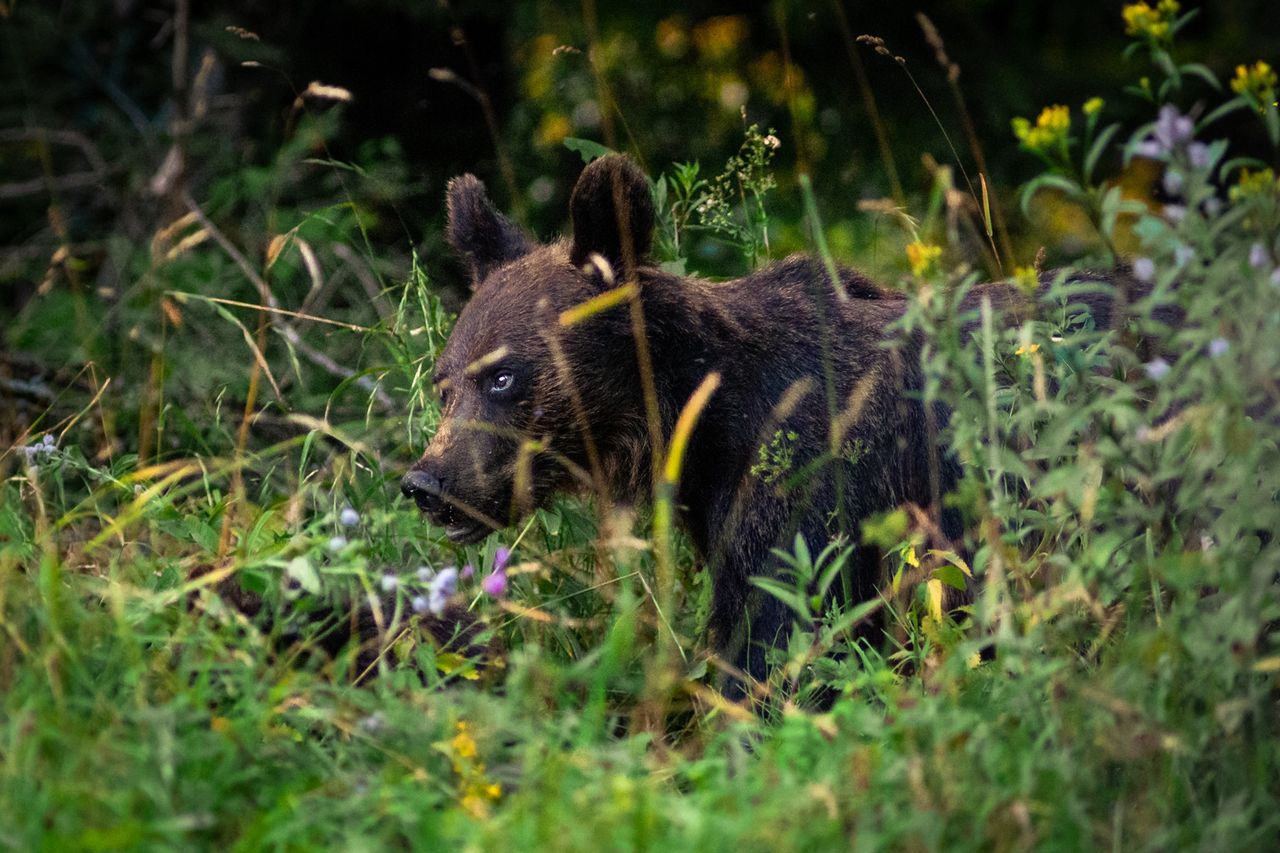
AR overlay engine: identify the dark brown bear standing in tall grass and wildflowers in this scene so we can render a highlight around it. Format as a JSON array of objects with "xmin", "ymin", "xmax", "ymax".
[{"xmin": 402, "ymin": 155, "xmax": 1131, "ymax": 696}]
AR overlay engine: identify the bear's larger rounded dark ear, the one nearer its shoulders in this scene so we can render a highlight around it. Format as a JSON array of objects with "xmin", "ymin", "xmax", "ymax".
[{"xmin": 568, "ymin": 154, "xmax": 654, "ymax": 280}]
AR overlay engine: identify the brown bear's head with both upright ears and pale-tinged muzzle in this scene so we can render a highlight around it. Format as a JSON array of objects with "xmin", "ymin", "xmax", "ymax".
[{"xmin": 401, "ymin": 155, "xmax": 654, "ymax": 542}]
